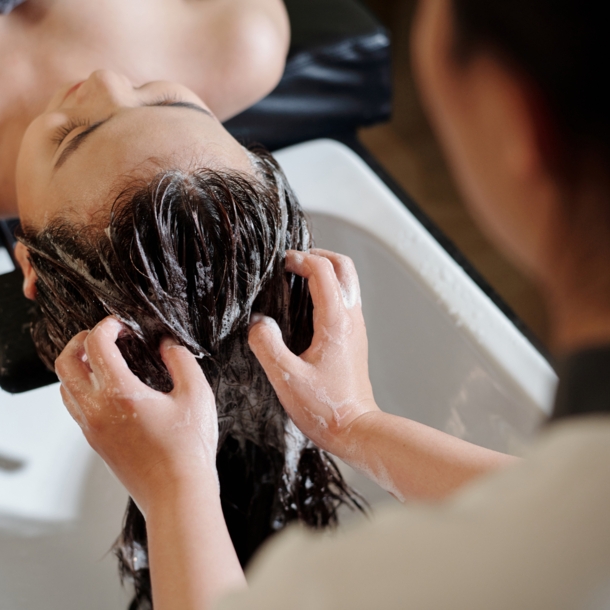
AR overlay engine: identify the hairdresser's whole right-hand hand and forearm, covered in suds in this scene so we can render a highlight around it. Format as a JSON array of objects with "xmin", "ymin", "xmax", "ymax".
[{"xmin": 249, "ymin": 249, "xmax": 514, "ymax": 499}]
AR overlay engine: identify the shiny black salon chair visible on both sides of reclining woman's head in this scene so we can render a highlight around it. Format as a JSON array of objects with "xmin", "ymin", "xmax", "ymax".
[{"xmin": 0, "ymin": 0, "xmax": 391, "ymax": 393}]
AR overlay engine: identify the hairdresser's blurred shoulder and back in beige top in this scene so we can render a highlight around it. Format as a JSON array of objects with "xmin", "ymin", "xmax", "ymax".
[{"xmin": 216, "ymin": 416, "xmax": 610, "ymax": 610}]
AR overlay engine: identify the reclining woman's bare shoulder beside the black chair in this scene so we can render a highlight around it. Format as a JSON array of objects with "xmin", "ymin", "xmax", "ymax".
[{"xmin": 176, "ymin": 0, "xmax": 290, "ymax": 120}]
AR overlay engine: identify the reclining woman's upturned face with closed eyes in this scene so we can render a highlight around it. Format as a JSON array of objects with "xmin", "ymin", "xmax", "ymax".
[{"xmin": 17, "ymin": 70, "xmax": 253, "ymax": 228}]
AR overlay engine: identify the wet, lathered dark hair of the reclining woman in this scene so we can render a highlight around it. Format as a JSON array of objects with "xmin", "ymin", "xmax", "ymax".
[{"xmin": 19, "ymin": 150, "xmax": 362, "ymax": 609}]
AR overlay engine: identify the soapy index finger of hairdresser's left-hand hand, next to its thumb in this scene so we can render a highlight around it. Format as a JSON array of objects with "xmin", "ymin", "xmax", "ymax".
[{"xmin": 84, "ymin": 316, "xmax": 142, "ymax": 390}]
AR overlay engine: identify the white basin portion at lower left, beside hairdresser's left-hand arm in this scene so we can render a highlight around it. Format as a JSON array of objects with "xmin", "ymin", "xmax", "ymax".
[{"xmin": 0, "ymin": 384, "xmax": 128, "ymax": 610}]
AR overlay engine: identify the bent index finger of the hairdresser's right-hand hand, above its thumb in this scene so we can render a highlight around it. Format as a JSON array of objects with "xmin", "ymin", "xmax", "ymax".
[{"xmin": 286, "ymin": 250, "xmax": 344, "ymax": 328}]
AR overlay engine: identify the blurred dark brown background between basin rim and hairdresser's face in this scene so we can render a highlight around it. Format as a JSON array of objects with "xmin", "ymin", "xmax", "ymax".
[{"xmin": 359, "ymin": 0, "xmax": 548, "ymax": 347}]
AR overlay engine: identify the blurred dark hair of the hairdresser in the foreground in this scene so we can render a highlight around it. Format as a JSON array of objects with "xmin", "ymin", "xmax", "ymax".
[{"xmin": 451, "ymin": 0, "xmax": 610, "ymax": 171}]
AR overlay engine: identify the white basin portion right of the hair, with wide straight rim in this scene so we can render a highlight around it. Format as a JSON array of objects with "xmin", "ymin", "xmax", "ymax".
[{"xmin": 276, "ymin": 140, "xmax": 557, "ymax": 502}]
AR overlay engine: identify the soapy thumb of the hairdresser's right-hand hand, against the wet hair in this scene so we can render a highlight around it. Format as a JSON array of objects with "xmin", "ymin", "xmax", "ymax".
[{"xmin": 248, "ymin": 314, "xmax": 307, "ymax": 384}]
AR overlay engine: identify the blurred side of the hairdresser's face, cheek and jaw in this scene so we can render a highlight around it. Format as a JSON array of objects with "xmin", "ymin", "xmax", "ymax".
[{"xmin": 412, "ymin": 0, "xmax": 523, "ymax": 264}]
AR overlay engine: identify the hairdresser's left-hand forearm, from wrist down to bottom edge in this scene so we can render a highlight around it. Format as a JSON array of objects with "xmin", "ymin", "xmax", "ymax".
[{"xmin": 146, "ymin": 472, "xmax": 246, "ymax": 610}]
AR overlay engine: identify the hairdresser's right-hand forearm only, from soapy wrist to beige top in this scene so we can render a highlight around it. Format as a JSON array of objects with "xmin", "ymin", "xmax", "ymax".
[{"xmin": 337, "ymin": 411, "xmax": 517, "ymax": 500}]
